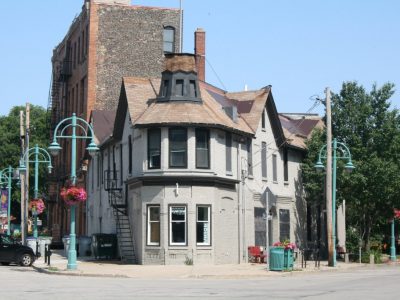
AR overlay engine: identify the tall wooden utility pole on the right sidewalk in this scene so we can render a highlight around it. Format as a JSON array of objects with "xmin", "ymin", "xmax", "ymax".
[{"xmin": 325, "ymin": 87, "xmax": 335, "ymax": 267}]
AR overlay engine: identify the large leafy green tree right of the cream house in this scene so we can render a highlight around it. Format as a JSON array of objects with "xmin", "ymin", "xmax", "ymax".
[{"xmin": 303, "ymin": 82, "xmax": 400, "ymax": 250}]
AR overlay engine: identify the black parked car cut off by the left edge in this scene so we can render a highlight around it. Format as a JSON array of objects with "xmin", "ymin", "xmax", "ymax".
[{"xmin": 0, "ymin": 234, "xmax": 35, "ymax": 267}]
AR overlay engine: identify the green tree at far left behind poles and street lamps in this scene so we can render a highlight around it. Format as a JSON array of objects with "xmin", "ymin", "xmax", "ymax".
[{"xmin": 0, "ymin": 105, "xmax": 49, "ymax": 222}]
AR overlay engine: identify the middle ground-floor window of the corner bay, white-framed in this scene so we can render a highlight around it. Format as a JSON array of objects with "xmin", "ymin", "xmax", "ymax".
[{"xmin": 169, "ymin": 205, "xmax": 186, "ymax": 246}]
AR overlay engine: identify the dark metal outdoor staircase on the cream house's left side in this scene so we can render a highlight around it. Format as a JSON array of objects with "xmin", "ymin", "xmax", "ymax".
[{"xmin": 105, "ymin": 170, "xmax": 137, "ymax": 264}]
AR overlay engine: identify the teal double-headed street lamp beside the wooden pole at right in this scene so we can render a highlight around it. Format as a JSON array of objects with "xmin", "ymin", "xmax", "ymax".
[{"xmin": 314, "ymin": 139, "xmax": 355, "ymax": 267}]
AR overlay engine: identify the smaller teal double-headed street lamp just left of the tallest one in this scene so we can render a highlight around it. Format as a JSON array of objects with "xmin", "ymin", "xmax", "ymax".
[{"xmin": 19, "ymin": 145, "xmax": 53, "ymax": 238}]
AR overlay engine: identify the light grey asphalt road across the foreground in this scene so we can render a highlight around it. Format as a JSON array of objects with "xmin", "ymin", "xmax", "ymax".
[{"xmin": 0, "ymin": 265, "xmax": 400, "ymax": 300}]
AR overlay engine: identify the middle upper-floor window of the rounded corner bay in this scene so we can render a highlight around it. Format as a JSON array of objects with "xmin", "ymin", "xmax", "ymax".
[{"xmin": 169, "ymin": 128, "xmax": 187, "ymax": 168}]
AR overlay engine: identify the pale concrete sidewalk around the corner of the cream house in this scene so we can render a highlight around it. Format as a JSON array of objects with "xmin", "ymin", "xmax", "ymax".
[{"xmin": 33, "ymin": 250, "xmax": 378, "ymax": 279}]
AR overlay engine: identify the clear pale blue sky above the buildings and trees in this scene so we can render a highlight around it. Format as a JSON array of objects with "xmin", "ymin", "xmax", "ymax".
[{"xmin": 0, "ymin": 0, "xmax": 400, "ymax": 115}]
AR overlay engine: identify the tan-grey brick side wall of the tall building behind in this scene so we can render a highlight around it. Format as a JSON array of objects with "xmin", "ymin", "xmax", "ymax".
[{"xmin": 92, "ymin": 5, "xmax": 180, "ymax": 110}]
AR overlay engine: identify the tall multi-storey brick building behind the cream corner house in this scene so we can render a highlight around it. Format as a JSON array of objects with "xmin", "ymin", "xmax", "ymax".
[{"xmin": 48, "ymin": 0, "xmax": 180, "ymax": 240}]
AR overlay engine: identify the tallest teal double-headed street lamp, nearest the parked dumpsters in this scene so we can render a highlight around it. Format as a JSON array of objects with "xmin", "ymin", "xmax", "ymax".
[{"xmin": 48, "ymin": 113, "xmax": 99, "ymax": 270}]
